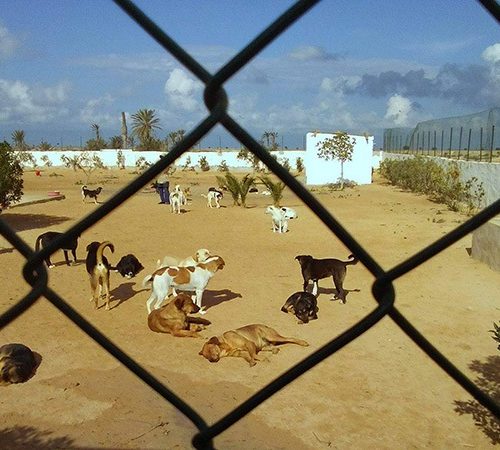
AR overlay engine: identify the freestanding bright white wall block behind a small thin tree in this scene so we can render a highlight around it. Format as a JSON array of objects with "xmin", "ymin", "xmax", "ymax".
[{"xmin": 304, "ymin": 133, "xmax": 373, "ymax": 185}]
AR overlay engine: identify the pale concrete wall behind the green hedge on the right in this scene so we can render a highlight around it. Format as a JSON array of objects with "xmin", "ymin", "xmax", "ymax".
[{"xmin": 381, "ymin": 152, "xmax": 500, "ymax": 206}]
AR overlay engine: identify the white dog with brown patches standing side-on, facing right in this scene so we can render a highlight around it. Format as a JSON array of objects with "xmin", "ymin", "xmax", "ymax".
[{"xmin": 142, "ymin": 255, "xmax": 225, "ymax": 314}]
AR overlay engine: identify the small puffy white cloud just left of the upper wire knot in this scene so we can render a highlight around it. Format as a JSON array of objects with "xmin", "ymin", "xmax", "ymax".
[{"xmin": 165, "ymin": 68, "xmax": 202, "ymax": 112}]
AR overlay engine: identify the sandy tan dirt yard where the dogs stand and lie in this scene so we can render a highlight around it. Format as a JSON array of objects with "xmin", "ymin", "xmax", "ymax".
[{"xmin": 0, "ymin": 168, "xmax": 500, "ymax": 449}]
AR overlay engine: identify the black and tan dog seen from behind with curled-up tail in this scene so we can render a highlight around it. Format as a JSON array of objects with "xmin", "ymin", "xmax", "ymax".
[{"xmin": 85, "ymin": 241, "xmax": 115, "ymax": 310}]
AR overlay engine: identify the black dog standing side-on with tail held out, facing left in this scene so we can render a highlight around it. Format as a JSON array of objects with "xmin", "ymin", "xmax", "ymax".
[{"xmin": 295, "ymin": 255, "xmax": 358, "ymax": 303}]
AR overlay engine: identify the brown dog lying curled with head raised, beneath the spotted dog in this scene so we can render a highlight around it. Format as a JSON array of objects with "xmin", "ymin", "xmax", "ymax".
[{"xmin": 148, "ymin": 293, "xmax": 211, "ymax": 337}]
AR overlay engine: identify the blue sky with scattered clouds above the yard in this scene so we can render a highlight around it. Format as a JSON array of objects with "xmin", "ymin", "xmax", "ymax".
[{"xmin": 0, "ymin": 0, "xmax": 500, "ymax": 148}]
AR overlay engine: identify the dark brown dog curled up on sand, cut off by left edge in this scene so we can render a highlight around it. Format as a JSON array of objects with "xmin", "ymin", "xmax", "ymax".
[{"xmin": 0, "ymin": 344, "xmax": 37, "ymax": 385}]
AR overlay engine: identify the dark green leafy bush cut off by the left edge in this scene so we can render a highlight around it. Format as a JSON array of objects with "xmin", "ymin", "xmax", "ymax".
[{"xmin": 0, "ymin": 141, "xmax": 23, "ymax": 212}]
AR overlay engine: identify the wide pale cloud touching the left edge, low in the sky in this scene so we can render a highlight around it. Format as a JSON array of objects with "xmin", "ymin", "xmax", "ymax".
[{"xmin": 0, "ymin": 79, "xmax": 69, "ymax": 123}]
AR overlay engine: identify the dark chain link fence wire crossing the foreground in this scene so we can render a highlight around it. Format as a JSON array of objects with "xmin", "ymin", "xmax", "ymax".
[{"xmin": 0, "ymin": 0, "xmax": 500, "ymax": 449}]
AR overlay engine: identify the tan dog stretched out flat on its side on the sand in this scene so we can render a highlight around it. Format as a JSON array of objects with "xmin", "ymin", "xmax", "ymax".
[{"xmin": 199, "ymin": 324, "xmax": 309, "ymax": 366}]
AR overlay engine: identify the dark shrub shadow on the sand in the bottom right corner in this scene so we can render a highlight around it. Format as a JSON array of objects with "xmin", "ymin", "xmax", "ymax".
[{"xmin": 454, "ymin": 356, "xmax": 500, "ymax": 445}]
